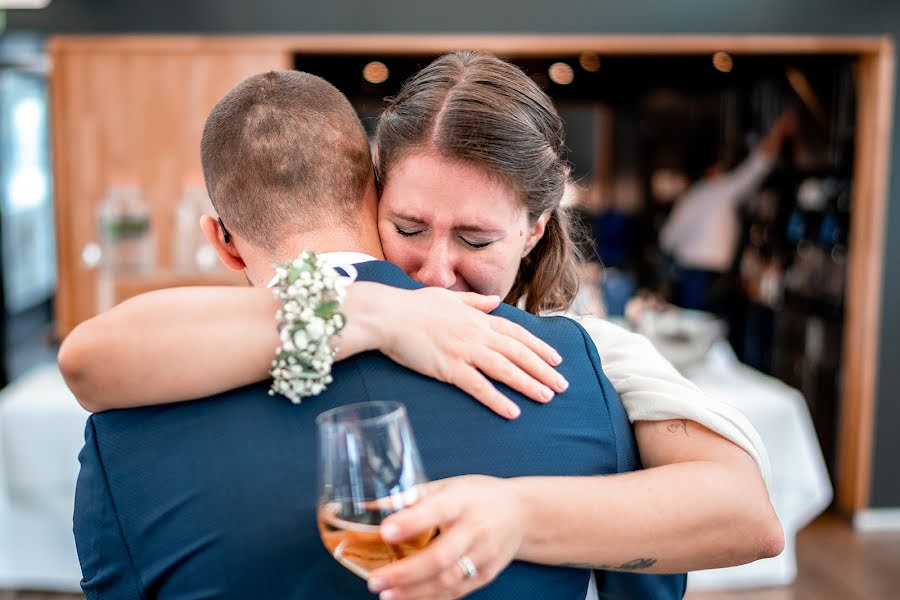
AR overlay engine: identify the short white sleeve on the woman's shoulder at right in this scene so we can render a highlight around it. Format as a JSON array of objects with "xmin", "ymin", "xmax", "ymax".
[{"xmin": 567, "ymin": 315, "xmax": 770, "ymax": 485}]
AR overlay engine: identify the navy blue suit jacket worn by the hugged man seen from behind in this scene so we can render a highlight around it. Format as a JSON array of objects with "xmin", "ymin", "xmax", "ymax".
[{"xmin": 74, "ymin": 261, "xmax": 685, "ymax": 600}]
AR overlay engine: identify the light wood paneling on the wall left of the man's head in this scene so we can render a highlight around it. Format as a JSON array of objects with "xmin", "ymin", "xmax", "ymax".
[{"xmin": 50, "ymin": 39, "xmax": 292, "ymax": 336}]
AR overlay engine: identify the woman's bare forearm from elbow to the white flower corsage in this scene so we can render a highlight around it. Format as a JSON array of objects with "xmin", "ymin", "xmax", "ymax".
[{"xmin": 59, "ymin": 287, "xmax": 279, "ymax": 412}]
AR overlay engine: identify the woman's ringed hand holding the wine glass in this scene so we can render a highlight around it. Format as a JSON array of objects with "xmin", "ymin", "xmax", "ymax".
[{"xmin": 369, "ymin": 475, "xmax": 524, "ymax": 600}]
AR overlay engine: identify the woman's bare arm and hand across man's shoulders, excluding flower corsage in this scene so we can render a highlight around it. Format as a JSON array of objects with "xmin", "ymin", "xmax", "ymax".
[{"xmin": 59, "ymin": 282, "xmax": 565, "ymax": 416}]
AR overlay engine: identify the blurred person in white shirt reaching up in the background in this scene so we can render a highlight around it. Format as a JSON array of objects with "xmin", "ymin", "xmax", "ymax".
[{"xmin": 659, "ymin": 110, "xmax": 797, "ymax": 315}]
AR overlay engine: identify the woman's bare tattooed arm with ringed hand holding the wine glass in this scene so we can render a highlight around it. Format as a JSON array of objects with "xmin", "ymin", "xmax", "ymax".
[{"xmin": 369, "ymin": 421, "xmax": 784, "ymax": 600}]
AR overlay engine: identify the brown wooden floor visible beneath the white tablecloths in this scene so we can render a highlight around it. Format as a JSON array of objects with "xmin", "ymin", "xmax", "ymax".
[{"xmin": 0, "ymin": 515, "xmax": 900, "ymax": 600}]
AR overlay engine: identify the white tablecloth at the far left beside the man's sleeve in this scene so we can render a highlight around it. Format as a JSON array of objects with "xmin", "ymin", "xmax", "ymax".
[{"xmin": 0, "ymin": 365, "xmax": 87, "ymax": 591}]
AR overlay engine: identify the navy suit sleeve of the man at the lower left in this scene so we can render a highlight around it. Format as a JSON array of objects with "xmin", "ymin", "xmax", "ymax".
[{"xmin": 73, "ymin": 417, "xmax": 144, "ymax": 600}]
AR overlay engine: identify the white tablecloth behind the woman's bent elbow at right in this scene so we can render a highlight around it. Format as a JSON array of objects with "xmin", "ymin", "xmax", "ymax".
[{"xmin": 685, "ymin": 342, "xmax": 832, "ymax": 589}]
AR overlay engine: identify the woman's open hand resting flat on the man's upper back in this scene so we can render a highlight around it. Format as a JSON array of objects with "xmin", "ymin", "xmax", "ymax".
[{"xmin": 348, "ymin": 282, "xmax": 568, "ymax": 418}]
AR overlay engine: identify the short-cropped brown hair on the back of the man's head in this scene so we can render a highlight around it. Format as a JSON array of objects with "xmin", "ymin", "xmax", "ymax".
[{"xmin": 200, "ymin": 71, "xmax": 372, "ymax": 252}]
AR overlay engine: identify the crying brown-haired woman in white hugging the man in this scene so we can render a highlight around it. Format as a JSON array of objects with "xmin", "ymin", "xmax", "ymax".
[{"xmin": 64, "ymin": 52, "xmax": 782, "ymax": 599}]
